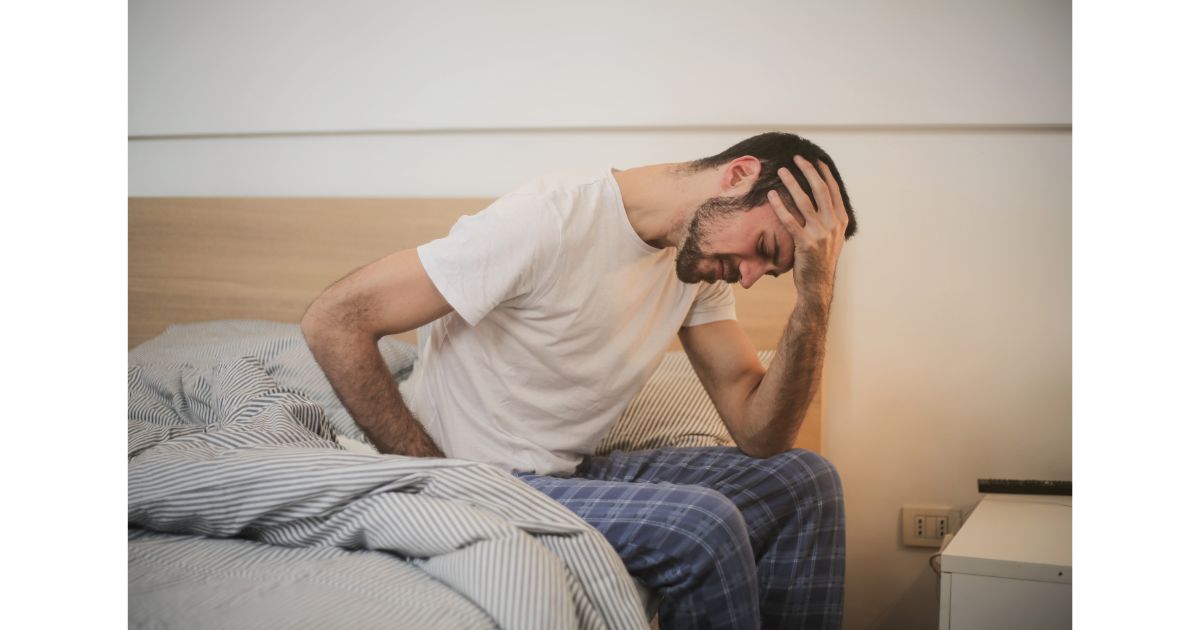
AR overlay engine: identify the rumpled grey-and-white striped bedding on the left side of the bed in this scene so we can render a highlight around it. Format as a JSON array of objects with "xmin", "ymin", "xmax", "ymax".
[{"xmin": 128, "ymin": 329, "xmax": 647, "ymax": 629}]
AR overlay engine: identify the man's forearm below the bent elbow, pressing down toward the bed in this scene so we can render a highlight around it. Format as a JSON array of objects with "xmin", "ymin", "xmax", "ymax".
[{"xmin": 305, "ymin": 329, "xmax": 445, "ymax": 457}]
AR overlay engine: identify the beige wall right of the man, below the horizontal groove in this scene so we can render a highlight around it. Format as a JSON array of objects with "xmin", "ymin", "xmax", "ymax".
[{"xmin": 826, "ymin": 132, "xmax": 1072, "ymax": 629}]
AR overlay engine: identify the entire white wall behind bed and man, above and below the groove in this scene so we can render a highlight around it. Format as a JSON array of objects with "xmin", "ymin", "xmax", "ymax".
[{"xmin": 130, "ymin": 0, "xmax": 1072, "ymax": 629}]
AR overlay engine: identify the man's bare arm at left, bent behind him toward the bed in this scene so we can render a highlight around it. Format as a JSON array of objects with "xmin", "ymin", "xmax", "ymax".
[{"xmin": 300, "ymin": 250, "xmax": 451, "ymax": 457}]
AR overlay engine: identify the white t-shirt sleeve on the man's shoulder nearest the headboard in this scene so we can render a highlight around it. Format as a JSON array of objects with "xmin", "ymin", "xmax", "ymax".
[{"xmin": 416, "ymin": 193, "xmax": 563, "ymax": 326}]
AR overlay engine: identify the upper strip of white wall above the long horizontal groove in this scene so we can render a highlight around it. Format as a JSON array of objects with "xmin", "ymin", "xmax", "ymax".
[{"xmin": 130, "ymin": 0, "xmax": 1070, "ymax": 136}]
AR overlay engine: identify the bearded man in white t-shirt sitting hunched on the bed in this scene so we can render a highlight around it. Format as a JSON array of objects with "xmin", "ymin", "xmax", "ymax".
[{"xmin": 302, "ymin": 133, "xmax": 857, "ymax": 628}]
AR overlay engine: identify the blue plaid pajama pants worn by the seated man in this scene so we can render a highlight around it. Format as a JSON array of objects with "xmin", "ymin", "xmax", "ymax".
[{"xmin": 518, "ymin": 448, "xmax": 846, "ymax": 629}]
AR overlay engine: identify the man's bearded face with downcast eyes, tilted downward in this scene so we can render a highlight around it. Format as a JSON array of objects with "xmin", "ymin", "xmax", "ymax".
[{"xmin": 676, "ymin": 197, "xmax": 796, "ymax": 288}]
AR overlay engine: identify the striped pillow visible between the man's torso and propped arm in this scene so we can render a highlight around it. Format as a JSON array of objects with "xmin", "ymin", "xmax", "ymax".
[{"xmin": 595, "ymin": 350, "xmax": 775, "ymax": 455}]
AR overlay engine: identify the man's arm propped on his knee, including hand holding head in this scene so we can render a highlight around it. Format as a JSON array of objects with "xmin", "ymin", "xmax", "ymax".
[{"xmin": 679, "ymin": 156, "xmax": 850, "ymax": 457}]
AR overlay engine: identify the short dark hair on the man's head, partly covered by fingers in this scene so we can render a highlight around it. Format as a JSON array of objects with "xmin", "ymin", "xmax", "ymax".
[{"xmin": 688, "ymin": 131, "xmax": 858, "ymax": 239}]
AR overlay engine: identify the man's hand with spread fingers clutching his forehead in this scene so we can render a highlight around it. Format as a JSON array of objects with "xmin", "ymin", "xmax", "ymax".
[{"xmin": 767, "ymin": 156, "xmax": 850, "ymax": 302}]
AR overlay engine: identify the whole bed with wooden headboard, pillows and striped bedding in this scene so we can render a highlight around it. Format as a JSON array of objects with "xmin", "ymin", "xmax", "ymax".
[{"xmin": 128, "ymin": 198, "xmax": 822, "ymax": 629}]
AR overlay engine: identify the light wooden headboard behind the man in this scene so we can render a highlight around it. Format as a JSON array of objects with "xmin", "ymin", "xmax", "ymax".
[{"xmin": 128, "ymin": 197, "xmax": 823, "ymax": 451}]
